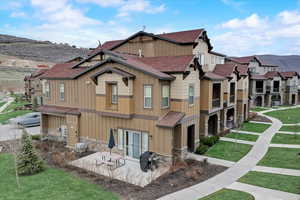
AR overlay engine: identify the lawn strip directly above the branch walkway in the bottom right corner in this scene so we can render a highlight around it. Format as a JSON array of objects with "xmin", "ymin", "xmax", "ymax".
[{"xmin": 239, "ymin": 171, "xmax": 300, "ymax": 194}]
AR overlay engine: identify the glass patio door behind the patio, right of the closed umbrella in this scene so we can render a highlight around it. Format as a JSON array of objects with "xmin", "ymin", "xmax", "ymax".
[{"xmin": 125, "ymin": 130, "xmax": 141, "ymax": 159}]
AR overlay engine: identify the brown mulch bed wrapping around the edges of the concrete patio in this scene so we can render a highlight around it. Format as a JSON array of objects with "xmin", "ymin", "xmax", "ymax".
[{"xmin": 0, "ymin": 141, "xmax": 227, "ymax": 200}]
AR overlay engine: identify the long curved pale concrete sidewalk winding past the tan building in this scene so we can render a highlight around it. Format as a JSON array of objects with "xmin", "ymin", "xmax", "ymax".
[{"xmin": 159, "ymin": 115, "xmax": 282, "ymax": 200}]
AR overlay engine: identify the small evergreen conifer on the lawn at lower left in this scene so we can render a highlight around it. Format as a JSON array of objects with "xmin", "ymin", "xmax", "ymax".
[{"xmin": 17, "ymin": 131, "xmax": 45, "ymax": 175}]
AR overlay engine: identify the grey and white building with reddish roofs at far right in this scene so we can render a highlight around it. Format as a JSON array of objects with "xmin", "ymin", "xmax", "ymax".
[{"xmin": 227, "ymin": 56, "xmax": 299, "ymax": 107}]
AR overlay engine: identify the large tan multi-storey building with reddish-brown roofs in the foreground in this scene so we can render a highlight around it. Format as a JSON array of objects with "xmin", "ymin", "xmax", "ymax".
[{"xmin": 40, "ymin": 29, "xmax": 249, "ymax": 159}]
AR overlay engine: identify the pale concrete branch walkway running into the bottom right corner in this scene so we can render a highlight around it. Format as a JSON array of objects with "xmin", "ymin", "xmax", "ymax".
[{"xmin": 226, "ymin": 182, "xmax": 300, "ymax": 200}]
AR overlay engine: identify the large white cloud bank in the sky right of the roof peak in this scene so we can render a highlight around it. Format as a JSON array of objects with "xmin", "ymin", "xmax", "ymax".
[{"xmin": 212, "ymin": 11, "xmax": 300, "ymax": 56}]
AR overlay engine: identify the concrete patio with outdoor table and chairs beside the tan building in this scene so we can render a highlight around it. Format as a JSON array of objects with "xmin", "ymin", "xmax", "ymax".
[{"xmin": 70, "ymin": 152, "xmax": 170, "ymax": 187}]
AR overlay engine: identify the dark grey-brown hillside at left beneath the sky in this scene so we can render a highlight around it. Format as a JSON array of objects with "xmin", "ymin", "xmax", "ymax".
[{"xmin": 0, "ymin": 34, "xmax": 88, "ymax": 63}]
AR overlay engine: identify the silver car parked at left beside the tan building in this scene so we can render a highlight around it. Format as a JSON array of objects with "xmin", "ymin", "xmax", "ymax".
[{"xmin": 9, "ymin": 112, "xmax": 41, "ymax": 127}]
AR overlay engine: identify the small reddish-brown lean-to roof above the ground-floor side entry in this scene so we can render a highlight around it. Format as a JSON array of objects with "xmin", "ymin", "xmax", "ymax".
[{"xmin": 156, "ymin": 111, "xmax": 185, "ymax": 128}]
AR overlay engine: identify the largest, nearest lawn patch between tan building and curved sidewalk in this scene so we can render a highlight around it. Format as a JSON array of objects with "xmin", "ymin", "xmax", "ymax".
[{"xmin": 205, "ymin": 141, "xmax": 252, "ymax": 162}]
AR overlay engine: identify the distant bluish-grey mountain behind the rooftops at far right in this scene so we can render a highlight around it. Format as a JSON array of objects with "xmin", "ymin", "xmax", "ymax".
[{"xmin": 258, "ymin": 55, "xmax": 300, "ymax": 74}]
